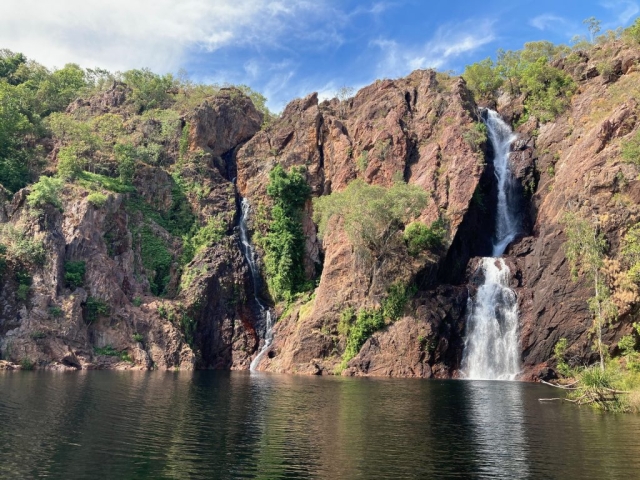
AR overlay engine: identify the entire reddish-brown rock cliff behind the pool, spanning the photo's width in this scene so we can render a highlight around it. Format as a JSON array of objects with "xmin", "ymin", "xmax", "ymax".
[{"xmin": 0, "ymin": 43, "xmax": 640, "ymax": 379}]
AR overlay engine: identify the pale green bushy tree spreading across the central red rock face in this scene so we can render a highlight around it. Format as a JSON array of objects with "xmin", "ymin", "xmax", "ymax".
[{"xmin": 313, "ymin": 180, "xmax": 427, "ymax": 261}]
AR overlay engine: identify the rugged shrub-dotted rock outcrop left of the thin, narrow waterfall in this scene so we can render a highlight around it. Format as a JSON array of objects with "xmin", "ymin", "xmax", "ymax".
[{"xmin": 0, "ymin": 86, "xmax": 262, "ymax": 369}]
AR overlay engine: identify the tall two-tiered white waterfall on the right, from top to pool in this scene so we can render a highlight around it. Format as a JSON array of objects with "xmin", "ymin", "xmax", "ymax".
[{"xmin": 462, "ymin": 110, "xmax": 521, "ymax": 380}]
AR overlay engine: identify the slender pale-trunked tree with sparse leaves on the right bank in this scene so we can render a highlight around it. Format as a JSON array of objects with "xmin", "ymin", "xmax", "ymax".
[{"xmin": 562, "ymin": 212, "xmax": 616, "ymax": 371}]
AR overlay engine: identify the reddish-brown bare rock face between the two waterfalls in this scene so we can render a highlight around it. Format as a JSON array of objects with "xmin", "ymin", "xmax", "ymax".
[{"xmin": 237, "ymin": 71, "xmax": 484, "ymax": 375}]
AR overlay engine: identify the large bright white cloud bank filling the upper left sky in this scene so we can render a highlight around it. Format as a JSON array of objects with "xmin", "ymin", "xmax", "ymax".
[{"xmin": 0, "ymin": 0, "xmax": 339, "ymax": 71}]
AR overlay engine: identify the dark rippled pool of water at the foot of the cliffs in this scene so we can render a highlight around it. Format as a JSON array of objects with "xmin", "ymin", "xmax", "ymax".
[{"xmin": 0, "ymin": 372, "xmax": 640, "ymax": 479}]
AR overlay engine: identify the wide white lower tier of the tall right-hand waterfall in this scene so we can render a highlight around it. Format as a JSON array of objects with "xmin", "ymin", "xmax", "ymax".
[{"xmin": 462, "ymin": 258, "xmax": 520, "ymax": 380}]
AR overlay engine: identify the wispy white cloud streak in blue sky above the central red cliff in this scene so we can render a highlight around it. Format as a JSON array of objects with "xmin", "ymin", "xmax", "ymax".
[{"xmin": 371, "ymin": 20, "xmax": 496, "ymax": 77}]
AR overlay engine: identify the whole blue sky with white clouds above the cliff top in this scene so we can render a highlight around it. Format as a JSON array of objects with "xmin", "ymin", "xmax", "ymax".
[{"xmin": 0, "ymin": 0, "xmax": 640, "ymax": 111}]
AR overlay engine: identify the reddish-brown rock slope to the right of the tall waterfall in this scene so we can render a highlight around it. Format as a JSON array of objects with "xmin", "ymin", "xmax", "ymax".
[{"xmin": 498, "ymin": 41, "xmax": 640, "ymax": 379}]
